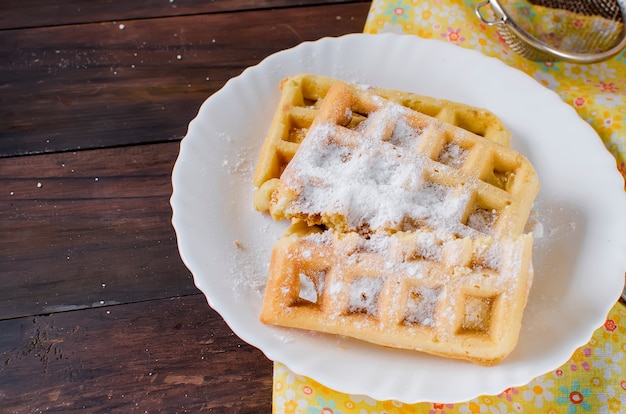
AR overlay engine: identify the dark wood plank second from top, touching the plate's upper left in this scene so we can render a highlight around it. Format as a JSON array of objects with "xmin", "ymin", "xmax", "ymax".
[{"xmin": 0, "ymin": 3, "xmax": 369, "ymax": 157}]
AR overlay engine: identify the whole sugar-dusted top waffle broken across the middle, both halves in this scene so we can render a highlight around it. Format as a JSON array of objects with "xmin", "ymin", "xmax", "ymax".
[{"xmin": 260, "ymin": 81, "xmax": 539, "ymax": 365}]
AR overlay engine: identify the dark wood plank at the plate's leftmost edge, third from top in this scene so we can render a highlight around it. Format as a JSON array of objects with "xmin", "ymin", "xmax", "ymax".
[{"xmin": 0, "ymin": 142, "xmax": 198, "ymax": 319}]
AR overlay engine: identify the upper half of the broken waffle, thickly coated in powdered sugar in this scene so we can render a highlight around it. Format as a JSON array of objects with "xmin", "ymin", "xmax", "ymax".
[{"xmin": 269, "ymin": 82, "xmax": 539, "ymax": 239}]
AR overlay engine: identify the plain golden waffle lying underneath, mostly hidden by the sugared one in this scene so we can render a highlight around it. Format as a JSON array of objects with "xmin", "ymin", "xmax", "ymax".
[{"xmin": 254, "ymin": 74, "xmax": 511, "ymax": 211}]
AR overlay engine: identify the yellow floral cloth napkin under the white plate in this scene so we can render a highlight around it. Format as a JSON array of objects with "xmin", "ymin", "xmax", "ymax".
[{"xmin": 273, "ymin": 0, "xmax": 626, "ymax": 414}]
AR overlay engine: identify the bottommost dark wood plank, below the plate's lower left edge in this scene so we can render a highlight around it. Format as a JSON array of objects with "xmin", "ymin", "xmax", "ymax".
[{"xmin": 0, "ymin": 295, "xmax": 272, "ymax": 413}]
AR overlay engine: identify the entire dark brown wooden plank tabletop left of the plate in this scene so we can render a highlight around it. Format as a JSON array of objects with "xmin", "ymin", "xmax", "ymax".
[{"xmin": 0, "ymin": 0, "xmax": 370, "ymax": 413}]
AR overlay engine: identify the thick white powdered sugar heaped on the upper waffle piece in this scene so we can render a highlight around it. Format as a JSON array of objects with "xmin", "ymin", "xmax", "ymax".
[{"xmin": 283, "ymin": 102, "xmax": 476, "ymax": 235}]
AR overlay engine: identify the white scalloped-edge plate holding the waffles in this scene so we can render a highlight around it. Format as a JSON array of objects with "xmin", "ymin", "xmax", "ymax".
[{"xmin": 171, "ymin": 34, "xmax": 626, "ymax": 403}]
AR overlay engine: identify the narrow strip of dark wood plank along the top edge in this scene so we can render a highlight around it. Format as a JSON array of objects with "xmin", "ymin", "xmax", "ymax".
[{"xmin": 0, "ymin": 0, "xmax": 364, "ymax": 29}]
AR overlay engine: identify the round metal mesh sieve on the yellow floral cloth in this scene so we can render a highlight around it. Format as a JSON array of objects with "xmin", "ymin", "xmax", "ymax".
[{"xmin": 475, "ymin": 0, "xmax": 626, "ymax": 63}]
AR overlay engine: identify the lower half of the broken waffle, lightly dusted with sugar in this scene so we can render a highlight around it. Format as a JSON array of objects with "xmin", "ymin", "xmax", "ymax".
[{"xmin": 261, "ymin": 223, "xmax": 533, "ymax": 365}]
